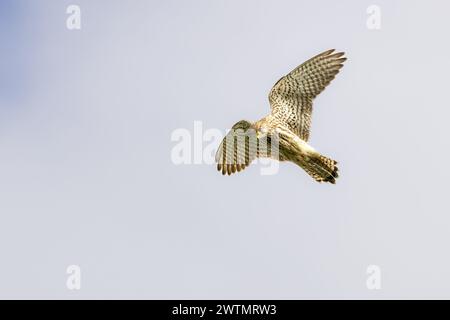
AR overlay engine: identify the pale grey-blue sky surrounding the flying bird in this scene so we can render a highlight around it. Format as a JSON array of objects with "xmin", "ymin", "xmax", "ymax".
[{"xmin": 0, "ymin": 0, "xmax": 450, "ymax": 299}]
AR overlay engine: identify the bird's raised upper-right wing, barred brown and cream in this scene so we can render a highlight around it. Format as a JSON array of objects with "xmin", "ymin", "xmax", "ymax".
[{"xmin": 269, "ymin": 49, "xmax": 346, "ymax": 141}]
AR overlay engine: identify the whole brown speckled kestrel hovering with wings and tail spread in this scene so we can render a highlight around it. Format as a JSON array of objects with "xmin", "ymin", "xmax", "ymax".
[{"xmin": 216, "ymin": 49, "xmax": 346, "ymax": 184}]
